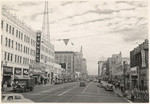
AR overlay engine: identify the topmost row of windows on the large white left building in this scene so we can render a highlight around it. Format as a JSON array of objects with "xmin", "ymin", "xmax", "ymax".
[{"xmin": 1, "ymin": 20, "xmax": 36, "ymax": 46}]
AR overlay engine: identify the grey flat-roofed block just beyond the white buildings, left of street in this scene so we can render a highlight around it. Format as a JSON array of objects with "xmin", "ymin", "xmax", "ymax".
[{"xmin": 55, "ymin": 51, "xmax": 75, "ymax": 79}]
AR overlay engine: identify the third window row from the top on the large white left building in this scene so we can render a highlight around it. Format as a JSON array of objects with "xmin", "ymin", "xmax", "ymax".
[{"xmin": 4, "ymin": 52, "xmax": 34, "ymax": 65}]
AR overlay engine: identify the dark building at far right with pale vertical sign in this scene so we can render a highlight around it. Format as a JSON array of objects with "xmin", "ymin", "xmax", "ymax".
[{"xmin": 130, "ymin": 39, "xmax": 149, "ymax": 89}]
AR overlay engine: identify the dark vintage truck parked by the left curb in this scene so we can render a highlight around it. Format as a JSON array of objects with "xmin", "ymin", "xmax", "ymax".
[{"xmin": 13, "ymin": 78, "xmax": 35, "ymax": 92}]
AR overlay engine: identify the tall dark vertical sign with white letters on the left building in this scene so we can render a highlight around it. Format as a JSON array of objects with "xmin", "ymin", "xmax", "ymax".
[{"xmin": 36, "ymin": 32, "xmax": 41, "ymax": 62}]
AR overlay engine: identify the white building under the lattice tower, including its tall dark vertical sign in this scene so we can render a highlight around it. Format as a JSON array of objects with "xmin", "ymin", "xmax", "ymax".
[{"xmin": 35, "ymin": 31, "xmax": 54, "ymax": 83}]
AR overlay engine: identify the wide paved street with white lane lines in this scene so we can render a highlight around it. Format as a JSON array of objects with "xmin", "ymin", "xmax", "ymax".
[{"xmin": 3, "ymin": 82, "xmax": 129, "ymax": 103}]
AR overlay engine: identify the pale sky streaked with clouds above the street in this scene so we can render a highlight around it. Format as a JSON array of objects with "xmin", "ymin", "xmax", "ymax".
[{"xmin": 1, "ymin": 0, "xmax": 148, "ymax": 75}]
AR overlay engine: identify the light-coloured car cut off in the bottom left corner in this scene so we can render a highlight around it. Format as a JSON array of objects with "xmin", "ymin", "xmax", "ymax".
[{"xmin": 1, "ymin": 94, "xmax": 33, "ymax": 103}]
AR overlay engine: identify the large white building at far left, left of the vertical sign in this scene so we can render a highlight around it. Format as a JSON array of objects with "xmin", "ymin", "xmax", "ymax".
[{"xmin": 1, "ymin": 7, "xmax": 36, "ymax": 85}]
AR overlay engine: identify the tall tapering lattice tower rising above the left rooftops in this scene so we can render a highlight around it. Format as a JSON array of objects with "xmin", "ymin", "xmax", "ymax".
[{"xmin": 42, "ymin": 1, "xmax": 50, "ymax": 42}]
